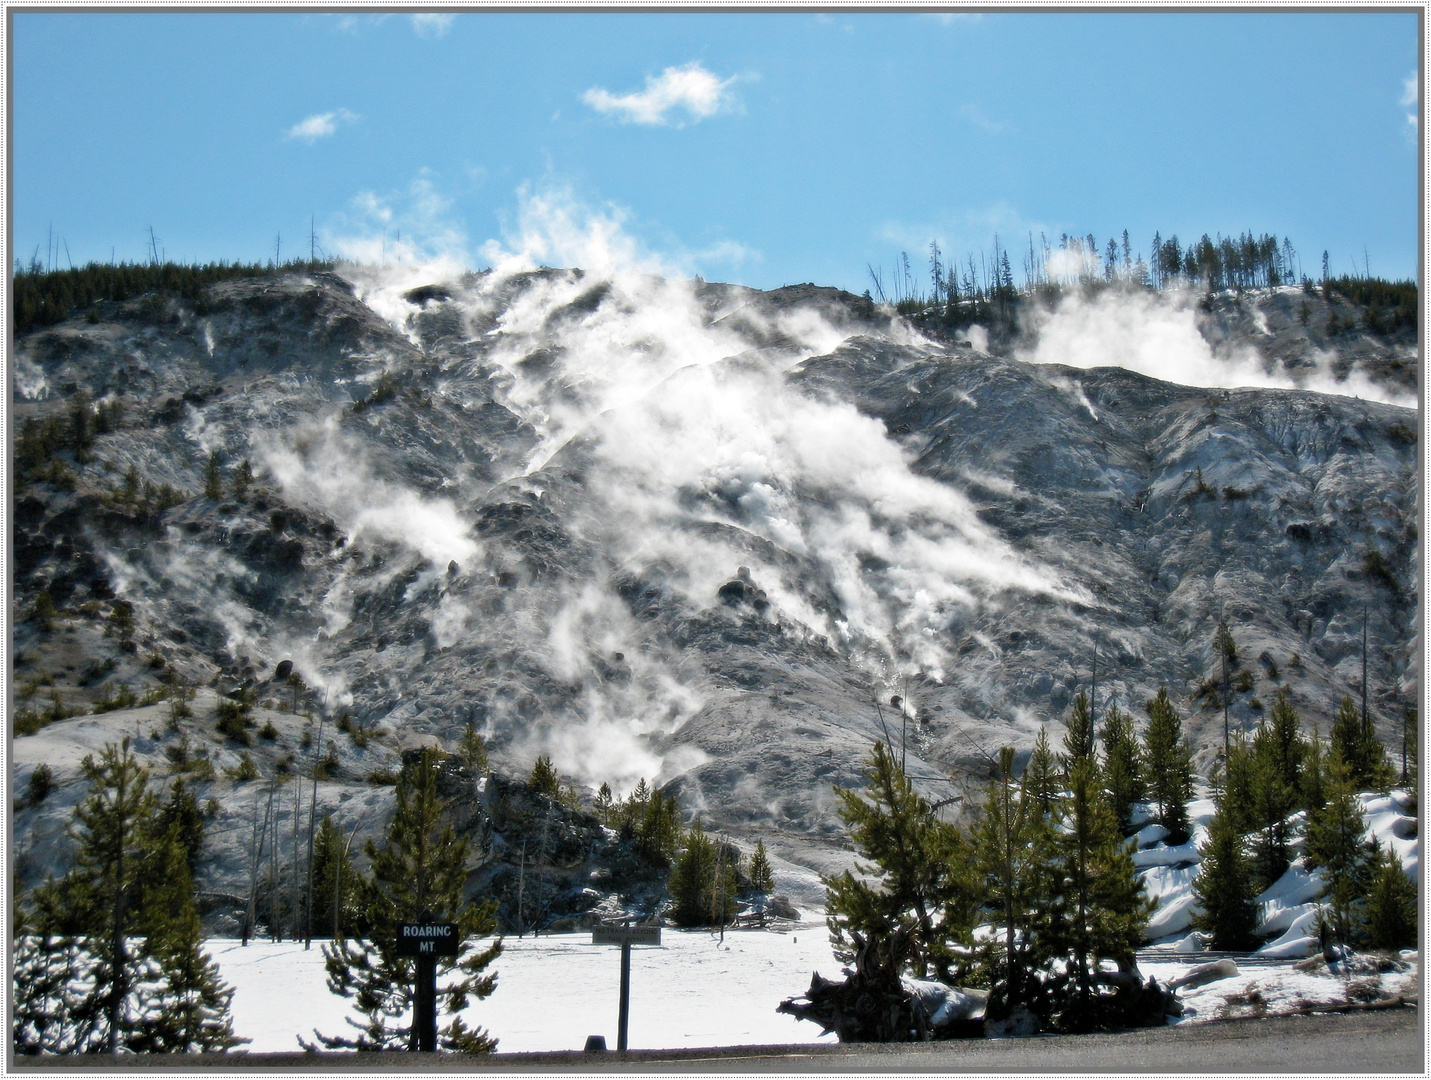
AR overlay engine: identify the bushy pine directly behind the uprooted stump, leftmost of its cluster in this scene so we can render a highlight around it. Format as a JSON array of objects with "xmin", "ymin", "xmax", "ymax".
[{"xmin": 821, "ymin": 742, "xmax": 973, "ymax": 980}]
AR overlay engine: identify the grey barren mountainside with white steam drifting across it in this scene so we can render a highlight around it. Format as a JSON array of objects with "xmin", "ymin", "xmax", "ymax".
[{"xmin": 13, "ymin": 270, "xmax": 1420, "ymax": 898}]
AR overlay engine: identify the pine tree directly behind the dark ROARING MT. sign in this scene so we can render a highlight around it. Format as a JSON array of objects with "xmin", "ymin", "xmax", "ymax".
[{"xmin": 309, "ymin": 748, "xmax": 502, "ymax": 1053}]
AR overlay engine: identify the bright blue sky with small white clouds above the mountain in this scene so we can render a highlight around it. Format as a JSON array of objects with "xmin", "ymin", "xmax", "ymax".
[{"xmin": 10, "ymin": 9, "xmax": 1420, "ymax": 292}]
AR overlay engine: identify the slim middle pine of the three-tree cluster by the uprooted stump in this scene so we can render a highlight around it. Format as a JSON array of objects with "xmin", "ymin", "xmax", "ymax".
[{"xmin": 975, "ymin": 747, "xmax": 1056, "ymax": 1020}]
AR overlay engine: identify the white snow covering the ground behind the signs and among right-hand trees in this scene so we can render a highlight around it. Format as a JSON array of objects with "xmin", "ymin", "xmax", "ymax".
[{"xmin": 209, "ymin": 792, "xmax": 1420, "ymax": 1053}]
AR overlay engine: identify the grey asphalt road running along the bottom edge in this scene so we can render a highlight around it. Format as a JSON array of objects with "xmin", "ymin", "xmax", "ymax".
[{"xmin": 11, "ymin": 1008, "xmax": 1425, "ymax": 1076}]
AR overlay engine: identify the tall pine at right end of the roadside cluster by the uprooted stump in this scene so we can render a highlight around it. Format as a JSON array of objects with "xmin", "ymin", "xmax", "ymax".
[{"xmin": 1047, "ymin": 757, "xmax": 1153, "ymax": 1031}]
